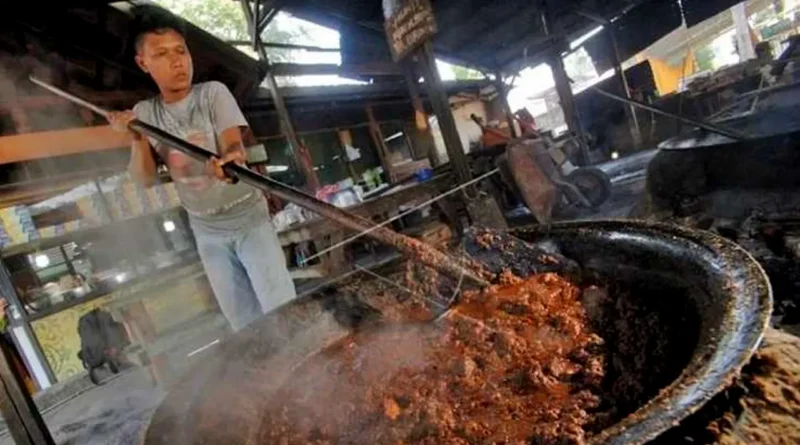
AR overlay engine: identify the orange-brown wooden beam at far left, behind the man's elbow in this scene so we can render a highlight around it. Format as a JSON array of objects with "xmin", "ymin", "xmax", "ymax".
[{"xmin": 0, "ymin": 125, "xmax": 131, "ymax": 165}]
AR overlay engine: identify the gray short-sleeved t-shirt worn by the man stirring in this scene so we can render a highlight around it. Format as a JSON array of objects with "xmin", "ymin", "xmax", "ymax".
[{"xmin": 133, "ymin": 82, "xmax": 268, "ymax": 232}]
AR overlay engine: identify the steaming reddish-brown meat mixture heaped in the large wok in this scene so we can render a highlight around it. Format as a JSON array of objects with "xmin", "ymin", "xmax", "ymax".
[{"xmin": 258, "ymin": 274, "xmax": 604, "ymax": 445}]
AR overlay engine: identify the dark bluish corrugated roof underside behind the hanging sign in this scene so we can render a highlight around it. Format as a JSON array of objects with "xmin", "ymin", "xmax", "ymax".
[{"xmin": 282, "ymin": 0, "xmax": 756, "ymax": 73}]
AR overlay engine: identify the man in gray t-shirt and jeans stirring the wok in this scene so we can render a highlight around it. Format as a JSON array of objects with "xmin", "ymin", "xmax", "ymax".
[{"xmin": 109, "ymin": 8, "xmax": 295, "ymax": 330}]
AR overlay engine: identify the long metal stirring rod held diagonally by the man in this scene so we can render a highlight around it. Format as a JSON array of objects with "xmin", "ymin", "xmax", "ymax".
[{"xmin": 30, "ymin": 77, "xmax": 489, "ymax": 287}]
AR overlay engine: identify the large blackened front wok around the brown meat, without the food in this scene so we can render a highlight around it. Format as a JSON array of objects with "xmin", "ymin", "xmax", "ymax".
[{"xmin": 146, "ymin": 221, "xmax": 772, "ymax": 445}]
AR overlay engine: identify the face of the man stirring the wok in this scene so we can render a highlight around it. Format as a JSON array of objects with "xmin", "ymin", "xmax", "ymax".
[{"xmin": 136, "ymin": 29, "xmax": 193, "ymax": 91}]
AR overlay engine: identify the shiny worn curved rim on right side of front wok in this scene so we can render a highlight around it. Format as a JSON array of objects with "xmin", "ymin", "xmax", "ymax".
[{"xmin": 508, "ymin": 219, "xmax": 773, "ymax": 445}]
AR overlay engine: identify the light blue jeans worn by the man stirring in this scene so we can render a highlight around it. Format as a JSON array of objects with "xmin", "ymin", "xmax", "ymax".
[{"xmin": 195, "ymin": 218, "xmax": 296, "ymax": 331}]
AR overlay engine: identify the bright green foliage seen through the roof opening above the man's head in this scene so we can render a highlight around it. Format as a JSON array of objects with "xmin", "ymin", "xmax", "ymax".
[{"xmin": 156, "ymin": 0, "xmax": 308, "ymax": 62}]
